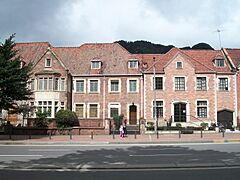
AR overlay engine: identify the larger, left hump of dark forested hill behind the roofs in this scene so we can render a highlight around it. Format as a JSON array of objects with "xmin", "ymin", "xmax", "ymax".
[{"xmin": 117, "ymin": 40, "xmax": 174, "ymax": 54}]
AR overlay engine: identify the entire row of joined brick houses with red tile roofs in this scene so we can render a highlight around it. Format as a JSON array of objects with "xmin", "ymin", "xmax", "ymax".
[{"xmin": 3, "ymin": 43, "xmax": 240, "ymax": 132}]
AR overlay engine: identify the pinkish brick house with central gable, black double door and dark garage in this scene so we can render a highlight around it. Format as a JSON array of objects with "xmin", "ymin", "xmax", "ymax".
[{"xmin": 144, "ymin": 48, "xmax": 237, "ymax": 128}]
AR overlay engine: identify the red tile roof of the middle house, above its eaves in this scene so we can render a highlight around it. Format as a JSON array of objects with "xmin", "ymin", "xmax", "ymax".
[{"xmin": 52, "ymin": 43, "xmax": 139, "ymax": 75}]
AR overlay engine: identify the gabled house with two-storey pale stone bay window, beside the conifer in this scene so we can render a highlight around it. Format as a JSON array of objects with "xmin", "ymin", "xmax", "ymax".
[{"xmin": 13, "ymin": 43, "xmax": 71, "ymax": 122}]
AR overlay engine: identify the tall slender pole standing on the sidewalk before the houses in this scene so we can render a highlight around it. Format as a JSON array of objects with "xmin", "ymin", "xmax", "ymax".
[{"xmin": 153, "ymin": 57, "xmax": 158, "ymax": 136}]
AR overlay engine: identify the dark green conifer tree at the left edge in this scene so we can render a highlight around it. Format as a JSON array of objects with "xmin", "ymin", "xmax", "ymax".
[{"xmin": 0, "ymin": 35, "xmax": 31, "ymax": 110}]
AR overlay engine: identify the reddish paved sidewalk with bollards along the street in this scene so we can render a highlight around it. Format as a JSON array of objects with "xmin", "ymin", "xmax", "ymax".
[{"xmin": 0, "ymin": 132, "xmax": 240, "ymax": 145}]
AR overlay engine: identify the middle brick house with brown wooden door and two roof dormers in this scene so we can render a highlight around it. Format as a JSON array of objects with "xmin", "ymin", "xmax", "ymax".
[{"xmin": 53, "ymin": 43, "xmax": 143, "ymax": 132}]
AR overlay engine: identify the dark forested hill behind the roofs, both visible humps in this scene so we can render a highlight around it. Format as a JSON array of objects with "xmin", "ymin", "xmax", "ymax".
[{"xmin": 116, "ymin": 40, "xmax": 213, "ymax": 54}]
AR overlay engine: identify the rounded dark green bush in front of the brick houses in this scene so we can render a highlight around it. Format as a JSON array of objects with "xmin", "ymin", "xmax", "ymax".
[{"xmin": 56, "ymin": 110, "xmax": 78, "ymax": 128}]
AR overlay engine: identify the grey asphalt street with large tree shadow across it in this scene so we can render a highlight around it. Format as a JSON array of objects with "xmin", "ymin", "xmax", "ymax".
[{"xmin": 0, "ymin": 143, "xmax": 240, "ymax": 180}]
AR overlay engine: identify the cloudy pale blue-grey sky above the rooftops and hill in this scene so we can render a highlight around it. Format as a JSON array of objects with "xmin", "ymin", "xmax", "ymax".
[{"xmin": 0, "ymin": 0, "xmax": 240, "ymax": 49}]
